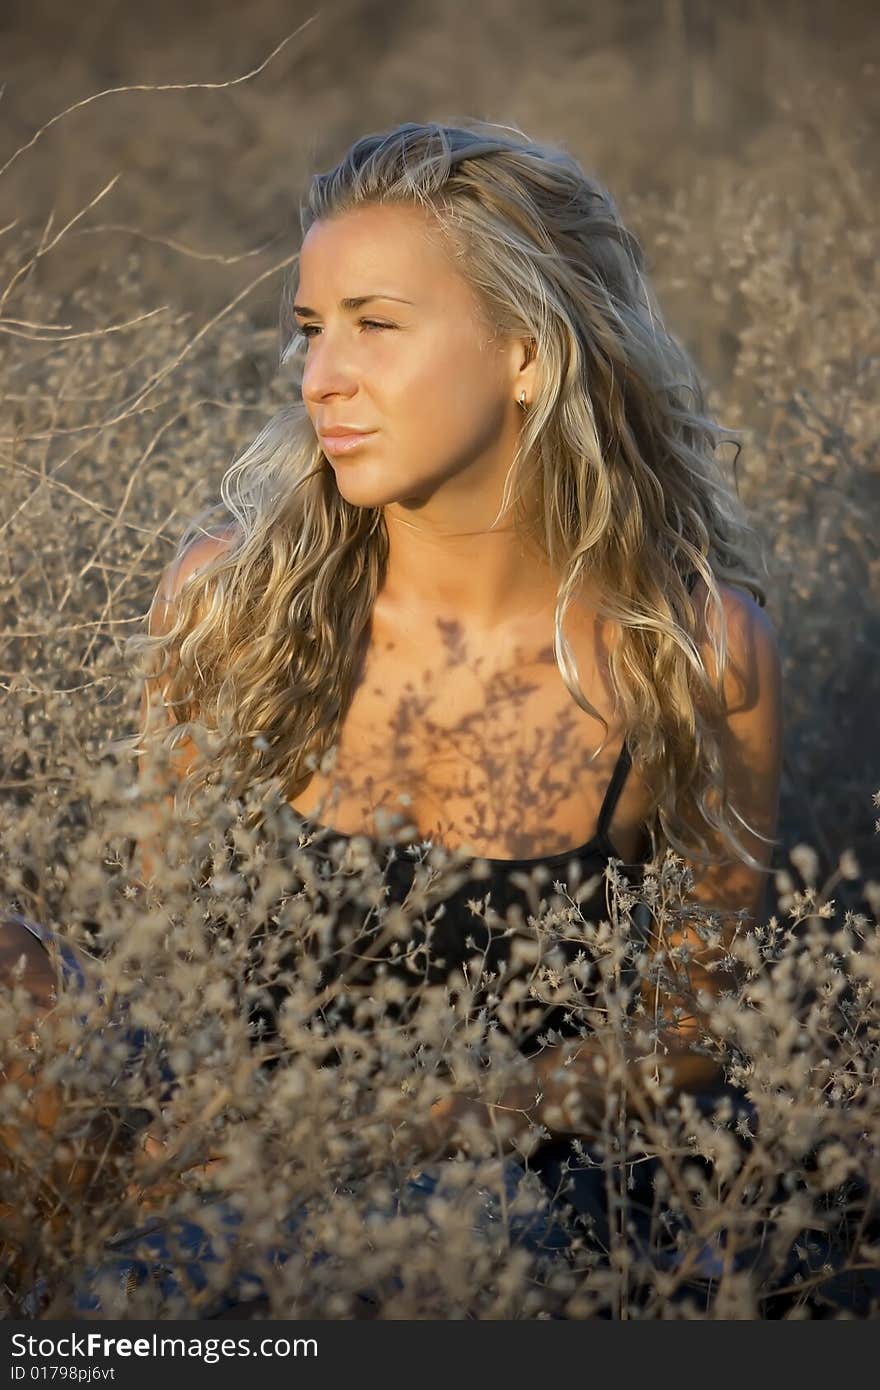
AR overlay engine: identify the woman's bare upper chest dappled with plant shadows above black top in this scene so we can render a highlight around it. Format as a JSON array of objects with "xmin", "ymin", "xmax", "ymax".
[{"xmin": 292, "ymin": 600, "xmax": 645, "ymax": 862}]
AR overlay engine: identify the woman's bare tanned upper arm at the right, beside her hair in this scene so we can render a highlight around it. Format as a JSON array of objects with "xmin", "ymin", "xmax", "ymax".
[{"xmin": 639, "ymin": 580, "xmax": 783, "ymax": 1031}]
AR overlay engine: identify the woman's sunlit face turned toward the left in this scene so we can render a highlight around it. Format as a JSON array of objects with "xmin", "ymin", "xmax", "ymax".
[{"xmin": 295, "ymin": 206, "xmax": 532, "ymax": 521}]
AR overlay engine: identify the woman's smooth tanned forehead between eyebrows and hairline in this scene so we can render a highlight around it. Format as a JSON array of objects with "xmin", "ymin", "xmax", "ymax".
[{"xmin": 298, "ymin": 204, "xmax": 464, "ymax": 296}]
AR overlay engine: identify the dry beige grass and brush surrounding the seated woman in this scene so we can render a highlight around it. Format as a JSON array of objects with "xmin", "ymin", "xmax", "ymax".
[{"xmin": 0, "ymin": 24, "xmax": 880, "ymax": 1318}]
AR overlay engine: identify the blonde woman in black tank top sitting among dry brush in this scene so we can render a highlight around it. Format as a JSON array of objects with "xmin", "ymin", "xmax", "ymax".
[{"xmin": 1, "ymin": 122, "xmax": 781, "ymax": 1312}]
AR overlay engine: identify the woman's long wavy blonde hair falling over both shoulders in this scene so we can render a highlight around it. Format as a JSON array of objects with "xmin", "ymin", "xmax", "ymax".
[{"xmin": 128, "ymin": 122, "xmax": 766, "ymax": 867}]
